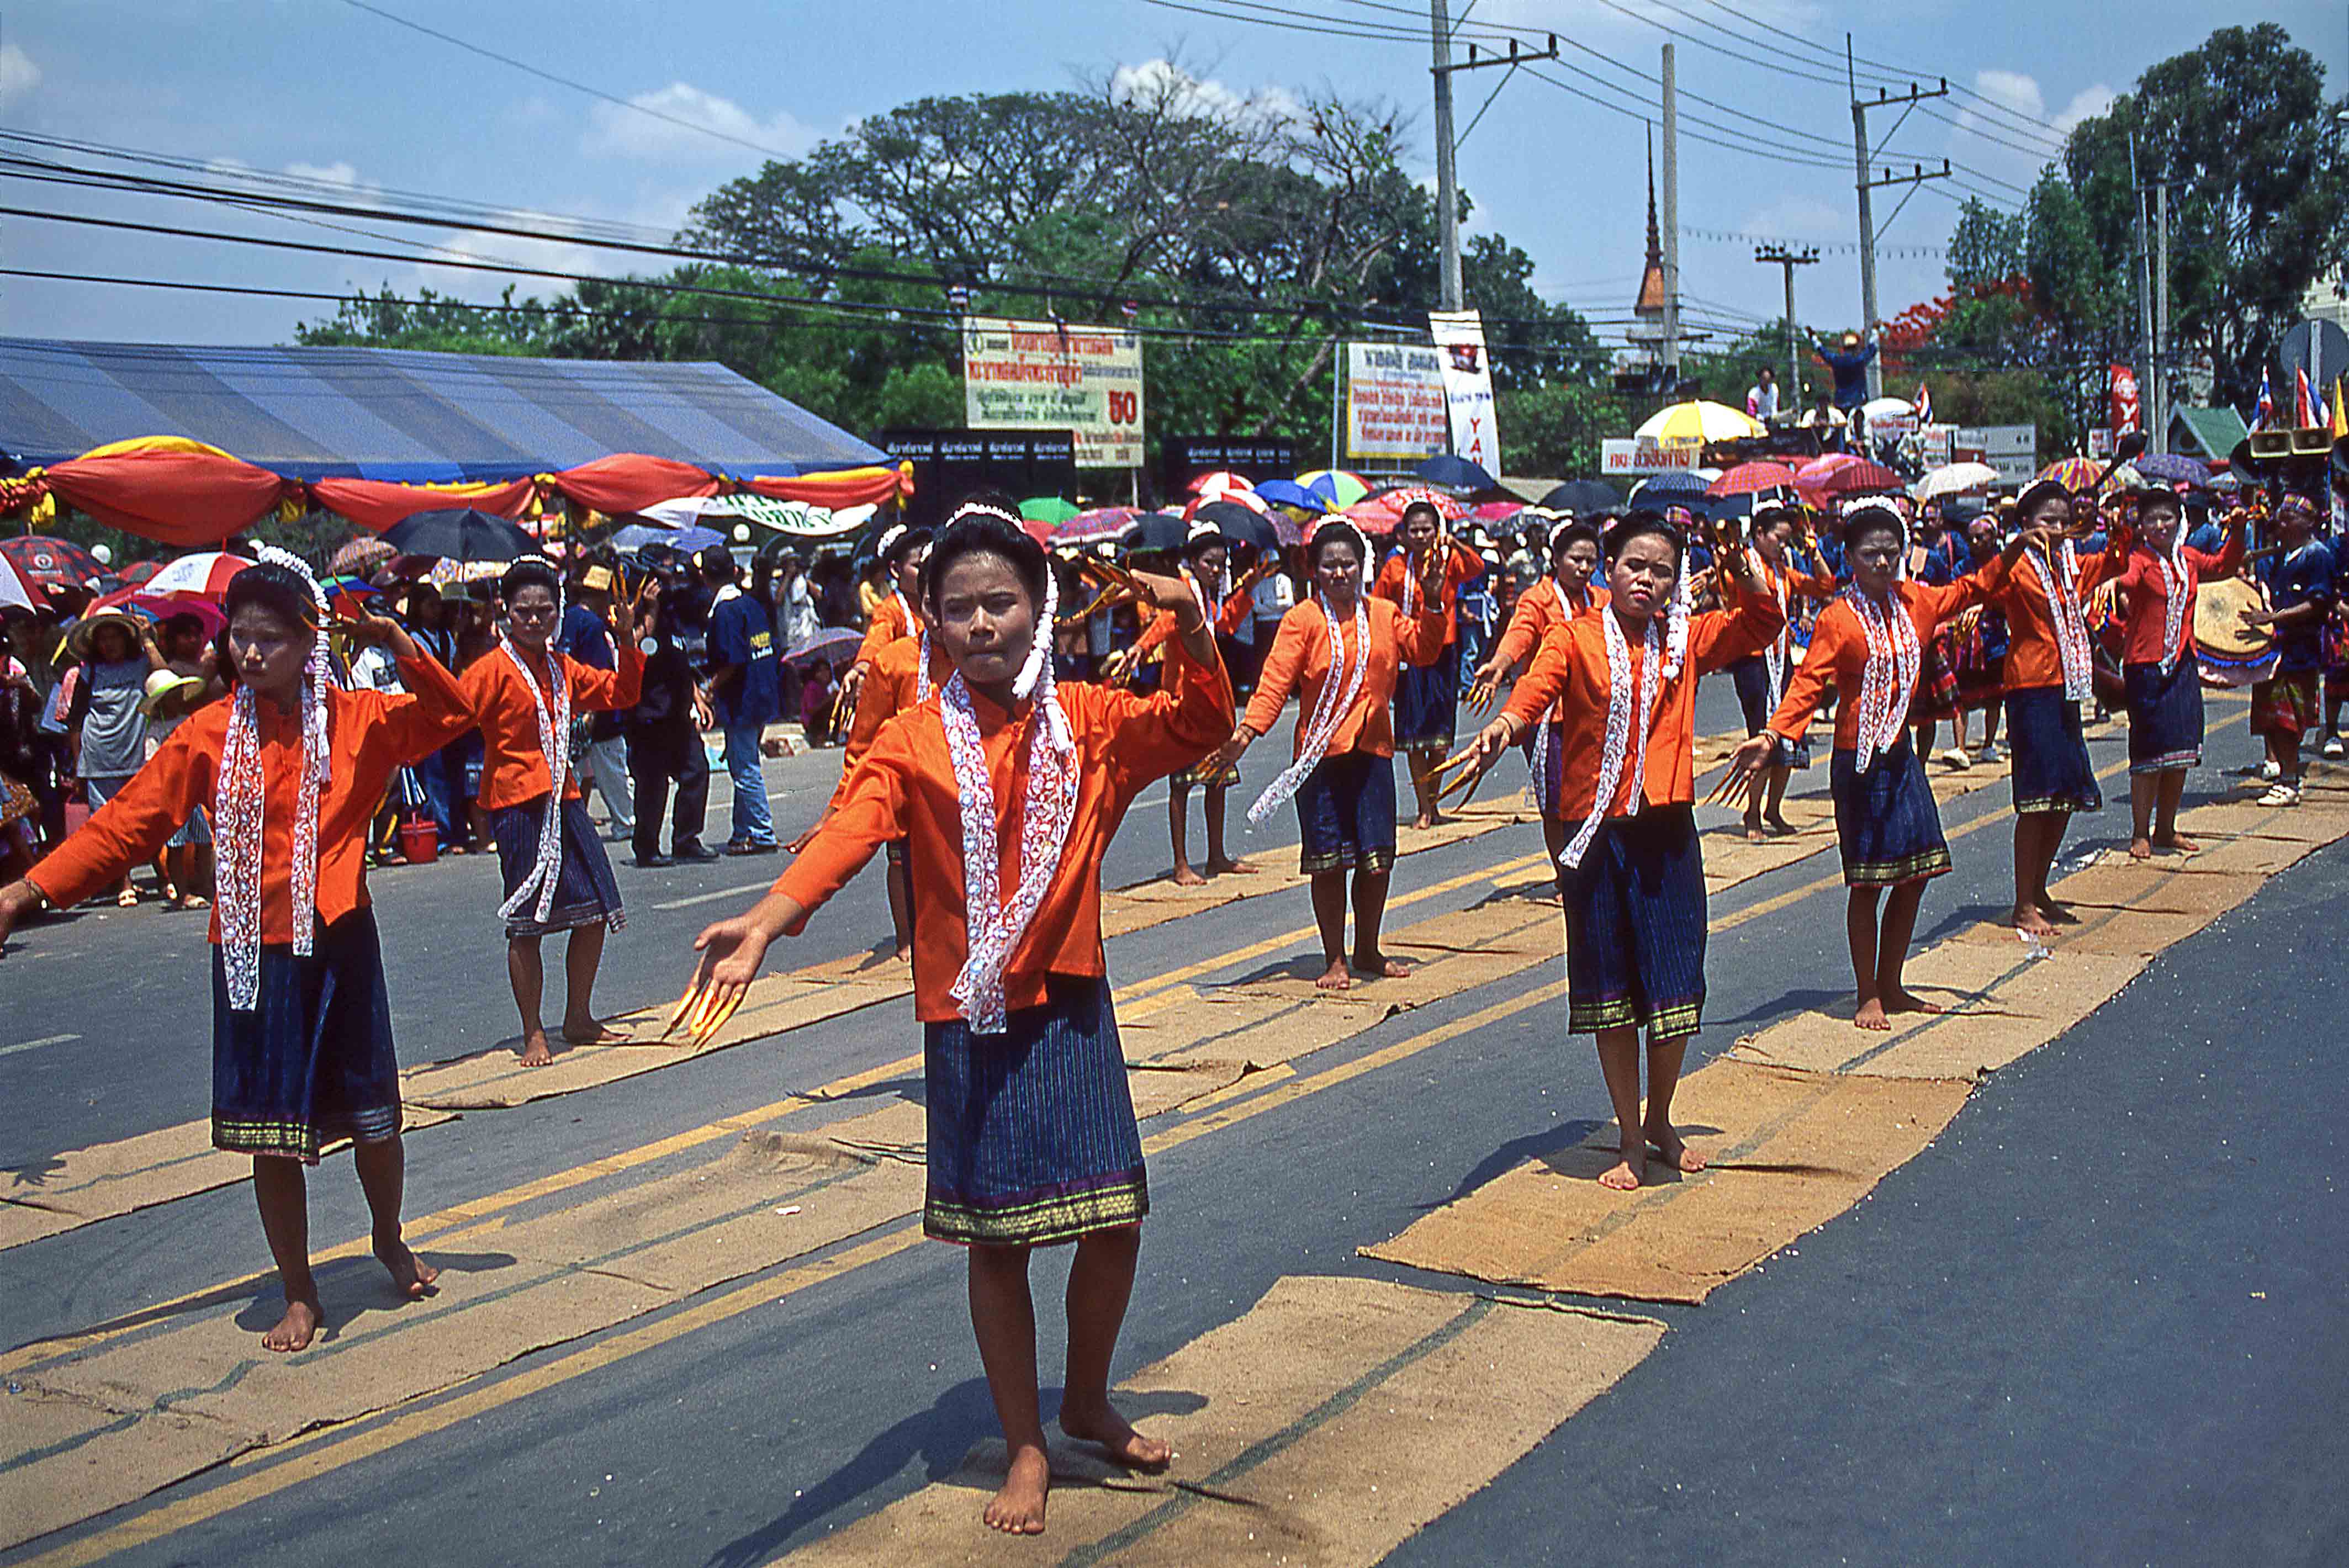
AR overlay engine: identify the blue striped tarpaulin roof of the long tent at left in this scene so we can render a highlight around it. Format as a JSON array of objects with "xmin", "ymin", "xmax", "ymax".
[{"xmin": 0, "ymin": 338, "xmax": 888, "ymax": 484}]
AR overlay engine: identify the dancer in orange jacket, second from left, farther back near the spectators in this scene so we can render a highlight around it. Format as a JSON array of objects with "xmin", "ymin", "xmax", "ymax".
[{"xmin": 463, "ymin": 557, "xmax": 644, "ymax": 1068}]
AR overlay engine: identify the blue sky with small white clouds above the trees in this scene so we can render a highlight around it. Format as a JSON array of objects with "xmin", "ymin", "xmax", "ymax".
[{"xmin": 0, "ymin": 0, "xmax": 2349, "ymax": 361}]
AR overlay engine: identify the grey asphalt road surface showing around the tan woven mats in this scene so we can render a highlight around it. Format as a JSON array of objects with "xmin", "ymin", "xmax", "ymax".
[{"xmin": 0, "ymin": 683, "xmax": 2349, "ymax": 1566}]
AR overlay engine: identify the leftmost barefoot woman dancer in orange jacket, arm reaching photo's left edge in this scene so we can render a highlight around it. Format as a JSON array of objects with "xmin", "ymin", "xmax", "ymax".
[{"xmin": 0, "ymin": 547, "xmax": 472, "ymax": 1352}]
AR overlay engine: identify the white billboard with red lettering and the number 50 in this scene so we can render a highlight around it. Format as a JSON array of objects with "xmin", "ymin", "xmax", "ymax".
[{"xmin": 963, "ymin": 317, "xmax": 1141, "ymax": 467}]
